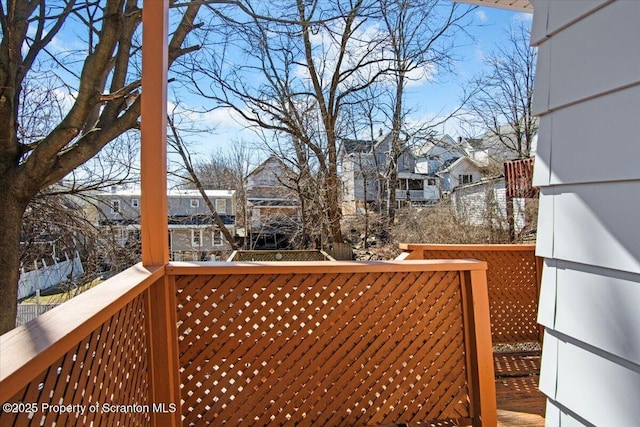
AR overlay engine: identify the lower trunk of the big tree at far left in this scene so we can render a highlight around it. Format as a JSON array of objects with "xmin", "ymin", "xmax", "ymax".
[{"xmin": 0, "ymin": 187, "xmax": 27, "ymax": 335}]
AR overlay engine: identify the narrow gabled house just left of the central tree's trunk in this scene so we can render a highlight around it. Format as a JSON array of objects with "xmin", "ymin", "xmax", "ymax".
[{"xmin": 242, "ymin": 156, "xmax": 302, "ymax": 249}]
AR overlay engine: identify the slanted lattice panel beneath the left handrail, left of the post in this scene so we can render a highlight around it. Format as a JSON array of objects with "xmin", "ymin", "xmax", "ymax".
[{"xmin": 0, "ymin": 296, "xmax": 150, "ymax": 426}]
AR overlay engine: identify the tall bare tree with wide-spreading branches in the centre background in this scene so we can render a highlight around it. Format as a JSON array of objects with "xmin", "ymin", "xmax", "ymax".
[{"xmin": 184, "ymin": 0, "xmax": 396, "ymax": 246}]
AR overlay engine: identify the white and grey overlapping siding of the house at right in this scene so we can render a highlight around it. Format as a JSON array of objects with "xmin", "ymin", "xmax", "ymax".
[{"xmin": 532, "ymin": 0, "xmax": 640, "ymax": 426}]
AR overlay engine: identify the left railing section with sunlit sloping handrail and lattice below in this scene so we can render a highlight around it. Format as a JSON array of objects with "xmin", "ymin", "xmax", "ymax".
[{"xmin": 0, "ymin": 265, "xmax": 179, "ymax": 426}]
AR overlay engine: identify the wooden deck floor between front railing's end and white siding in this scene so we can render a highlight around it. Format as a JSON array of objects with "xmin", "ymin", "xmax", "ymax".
[{"xmin": 494, "ymin": 352, "xmax": 546, "ymax": 427}]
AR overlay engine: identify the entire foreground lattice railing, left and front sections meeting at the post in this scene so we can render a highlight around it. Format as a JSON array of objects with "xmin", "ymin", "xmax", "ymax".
[{"xmin": 0, "ymin": 261, "xmax": 496, "ymax": 426}]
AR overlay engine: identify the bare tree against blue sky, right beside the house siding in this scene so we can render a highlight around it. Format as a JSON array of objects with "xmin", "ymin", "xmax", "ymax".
[{"xmin": 470, "ymin": 23, "xmax": 538, "ymax": 159}]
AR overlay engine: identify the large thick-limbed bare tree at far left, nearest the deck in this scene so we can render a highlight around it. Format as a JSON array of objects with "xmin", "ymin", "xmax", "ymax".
[{"xmin": 0, "ymin": 0, "xmax": 201, "ymax": 333}]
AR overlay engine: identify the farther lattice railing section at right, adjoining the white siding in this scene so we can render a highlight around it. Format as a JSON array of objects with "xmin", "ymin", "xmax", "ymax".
[{"xmin": 398, "ymin": 243, "xmax": 543, "ymax": 344}]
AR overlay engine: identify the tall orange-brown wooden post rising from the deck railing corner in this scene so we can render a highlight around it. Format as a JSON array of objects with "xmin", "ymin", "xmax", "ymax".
[{"xmin": 140, "ymin": 0, "xmax": 182, "ymax": 426}]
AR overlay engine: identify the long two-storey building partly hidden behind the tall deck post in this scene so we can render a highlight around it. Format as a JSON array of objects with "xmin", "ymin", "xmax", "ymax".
[{"xmin": 95, "ymin": 187, "xmax": 235, "ymax": 261}]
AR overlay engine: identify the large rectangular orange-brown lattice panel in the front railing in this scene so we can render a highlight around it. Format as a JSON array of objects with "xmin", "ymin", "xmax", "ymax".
[{"xmin": 176, "ymin": 272, "xmax": 470, "ymax": 426}]
